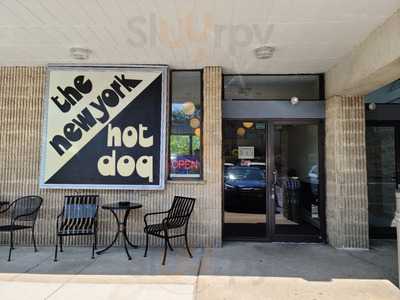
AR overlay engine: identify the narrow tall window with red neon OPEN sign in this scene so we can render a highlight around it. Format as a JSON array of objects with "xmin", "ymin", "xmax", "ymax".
[{"xmin": 169, "ymin": 70, "xmax": 203, "ymax": 179}]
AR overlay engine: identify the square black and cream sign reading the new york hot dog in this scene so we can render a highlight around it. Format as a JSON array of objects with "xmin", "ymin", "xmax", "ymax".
[{"xmin": 40, "ymin": 65, "xmax": 167, "ymax": 189}]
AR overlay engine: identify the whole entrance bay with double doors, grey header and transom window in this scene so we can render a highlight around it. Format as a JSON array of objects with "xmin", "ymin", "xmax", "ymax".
[{"xmin": 223, "ymin": 75, "xmax": 326, "ymax": 242}]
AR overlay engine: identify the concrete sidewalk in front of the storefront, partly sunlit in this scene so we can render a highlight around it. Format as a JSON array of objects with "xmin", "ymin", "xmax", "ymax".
[{"xmin": 0, "ymin": 241, "xmax": 400, "ymax": 300}]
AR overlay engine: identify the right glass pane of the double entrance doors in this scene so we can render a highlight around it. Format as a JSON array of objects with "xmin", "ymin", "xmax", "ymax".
[{"xmin": 272, "ymin": 122, "xmax": 324, "ymax": 241}]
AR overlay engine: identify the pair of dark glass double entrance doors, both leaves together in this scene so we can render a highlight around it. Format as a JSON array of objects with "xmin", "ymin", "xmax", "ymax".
[{"xmin": 223, "ymin": 120, "xmax": 324, "ymax": 241}]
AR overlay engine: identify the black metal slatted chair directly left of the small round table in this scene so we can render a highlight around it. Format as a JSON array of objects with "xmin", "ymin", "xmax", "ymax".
[{"xmin": 54, "ymin": 195, "xmax": 99, "ymax": 261}]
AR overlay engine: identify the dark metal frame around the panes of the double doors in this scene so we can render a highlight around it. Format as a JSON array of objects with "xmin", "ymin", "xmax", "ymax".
[{"xmin": 221, "ymin": 118, "xmax": 327, "ymax": 243}]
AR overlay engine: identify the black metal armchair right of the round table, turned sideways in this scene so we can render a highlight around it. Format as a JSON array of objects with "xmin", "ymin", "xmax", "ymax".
[{"xmin": 144, "ymin": 196, "xmax": 196, "ymax": 265}]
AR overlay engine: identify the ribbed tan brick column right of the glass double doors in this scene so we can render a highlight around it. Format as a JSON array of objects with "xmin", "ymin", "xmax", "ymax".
[{"xmin": 325, "ymin": 96, "xmax": 369, "ymax": 248}]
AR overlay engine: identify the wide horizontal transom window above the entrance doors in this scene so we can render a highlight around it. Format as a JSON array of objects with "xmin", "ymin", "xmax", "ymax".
[{"xmin": 224, "ymin": 75, "xmax": 324, "ymax": 100}]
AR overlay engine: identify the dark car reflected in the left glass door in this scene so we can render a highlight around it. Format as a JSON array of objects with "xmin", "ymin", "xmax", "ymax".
[{"xmin": 224, "ymin": 166, "xmax": 266, "ymax": 213}]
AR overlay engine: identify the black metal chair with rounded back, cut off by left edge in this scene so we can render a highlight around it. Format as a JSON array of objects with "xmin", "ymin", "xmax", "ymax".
[{"xmin": 0, "ymin": 196, "xmax": 43, "ymax": 261}]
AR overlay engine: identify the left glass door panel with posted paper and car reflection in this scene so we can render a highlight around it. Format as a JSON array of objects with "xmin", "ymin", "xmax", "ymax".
[{"xmin": 223, "ymin": 120, "xmax": 268, "ymax": 239}]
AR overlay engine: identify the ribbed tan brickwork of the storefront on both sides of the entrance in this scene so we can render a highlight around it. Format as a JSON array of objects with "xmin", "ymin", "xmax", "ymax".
[{"xmin": 0, "ymin": 66, "xmax": 390, "ymax": 248}]
